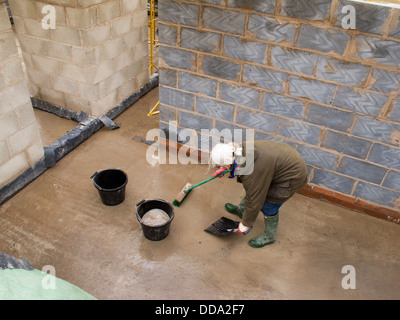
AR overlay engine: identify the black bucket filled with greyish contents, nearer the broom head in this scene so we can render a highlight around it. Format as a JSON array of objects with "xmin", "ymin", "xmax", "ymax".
[{"xmin": 136, "ymin": 199, "xmax": 174, "ymax": 241}]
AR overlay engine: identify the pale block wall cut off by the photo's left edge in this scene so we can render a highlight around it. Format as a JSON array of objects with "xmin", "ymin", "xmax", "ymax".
[{"xmin": 0, "ymin": 1, "xmax": 44, "ymax": 188}]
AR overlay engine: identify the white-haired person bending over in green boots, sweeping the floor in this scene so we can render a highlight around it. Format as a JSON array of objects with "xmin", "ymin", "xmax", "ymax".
[{"xmin": 210, "ymin": 140, "xmax": 307, "ymax": 248}]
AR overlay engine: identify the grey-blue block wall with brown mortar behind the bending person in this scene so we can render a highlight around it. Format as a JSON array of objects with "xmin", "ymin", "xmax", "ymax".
[{"xmin": 159, "ymin": 0, "xmax": 400, "ymax": 221}]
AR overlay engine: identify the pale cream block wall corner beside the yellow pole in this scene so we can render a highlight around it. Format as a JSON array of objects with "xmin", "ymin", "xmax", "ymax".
[{"xmin": 9, "ymin": 0, "xmax": 149, "ymax": 117}]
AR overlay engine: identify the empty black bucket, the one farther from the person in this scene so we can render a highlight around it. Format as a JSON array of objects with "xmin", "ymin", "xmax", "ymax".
[{"xmin": 90, "ymin": 169, "xmax": 128, "ymax": 206}]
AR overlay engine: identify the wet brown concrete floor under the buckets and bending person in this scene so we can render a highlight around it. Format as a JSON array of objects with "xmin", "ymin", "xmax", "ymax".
[{"xmin": 0, "ymin": 88, "xmax": 400, "ymax": 300}]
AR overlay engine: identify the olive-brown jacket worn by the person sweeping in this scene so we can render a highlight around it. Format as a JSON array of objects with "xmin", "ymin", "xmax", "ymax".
[{"xmin": 237, "ymin": 140, "xmax": 307, "ymax": 226}]
